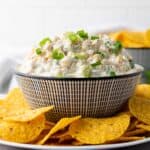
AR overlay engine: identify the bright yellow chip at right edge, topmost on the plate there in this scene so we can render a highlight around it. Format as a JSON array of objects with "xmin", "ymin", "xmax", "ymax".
[{"xmin": 135, "ymin": 84, "xmax": 150, "ymax": 99}]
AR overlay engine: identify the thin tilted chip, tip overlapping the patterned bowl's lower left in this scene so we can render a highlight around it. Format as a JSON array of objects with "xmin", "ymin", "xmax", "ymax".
[{"xmin": 4, "ymin": 106, "xmax": 53, "ymax": 122}]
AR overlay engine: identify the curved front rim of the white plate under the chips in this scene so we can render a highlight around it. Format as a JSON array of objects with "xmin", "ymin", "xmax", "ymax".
[{"xmin": 0, "ymin": 138, "xmax": 150, "ymax": 150}]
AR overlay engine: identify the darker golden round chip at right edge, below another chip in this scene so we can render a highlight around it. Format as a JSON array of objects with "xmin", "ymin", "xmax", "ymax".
[{"xmin": 129, "ymin": 96, "xmax": 150, "ymax": 125}]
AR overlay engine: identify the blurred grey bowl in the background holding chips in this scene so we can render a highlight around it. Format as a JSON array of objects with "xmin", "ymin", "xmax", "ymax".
[{"xmin": 126, "ymin": 48, "xmax": 150, "ymax": 82}]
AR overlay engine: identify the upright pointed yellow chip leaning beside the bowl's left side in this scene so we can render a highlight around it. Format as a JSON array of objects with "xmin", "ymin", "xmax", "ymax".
[{"xmin": 0, "ymin": 88, "xmax": 30, "ymax": 118}]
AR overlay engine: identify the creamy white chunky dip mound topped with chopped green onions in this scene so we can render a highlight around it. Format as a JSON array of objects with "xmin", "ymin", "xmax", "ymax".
[{"xmin": 18, "ymin": 30, "xmax": 140, "ymax": 78}]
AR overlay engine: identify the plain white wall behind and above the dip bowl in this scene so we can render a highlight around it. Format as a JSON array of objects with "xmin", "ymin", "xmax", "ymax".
[{"xmin": 0, "ymin": 0, "xmax": 150, "ymax": 55}]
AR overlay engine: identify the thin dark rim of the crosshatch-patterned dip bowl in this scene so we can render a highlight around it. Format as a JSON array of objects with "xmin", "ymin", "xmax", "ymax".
[{"xmin": 15, "ymin": 70, "xmax": 143, "ymax": 80}]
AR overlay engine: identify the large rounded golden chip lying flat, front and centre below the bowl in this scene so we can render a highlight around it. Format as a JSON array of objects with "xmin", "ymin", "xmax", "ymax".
[{"xmin": 69, "ymin": 113, "xmax": 130, "ymax": 144}]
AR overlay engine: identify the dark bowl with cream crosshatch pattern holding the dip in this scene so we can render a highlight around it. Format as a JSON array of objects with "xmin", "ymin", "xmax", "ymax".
[{"xmin": 16, "ymin": 71, "xmax": 141, "ymax": 121}]
